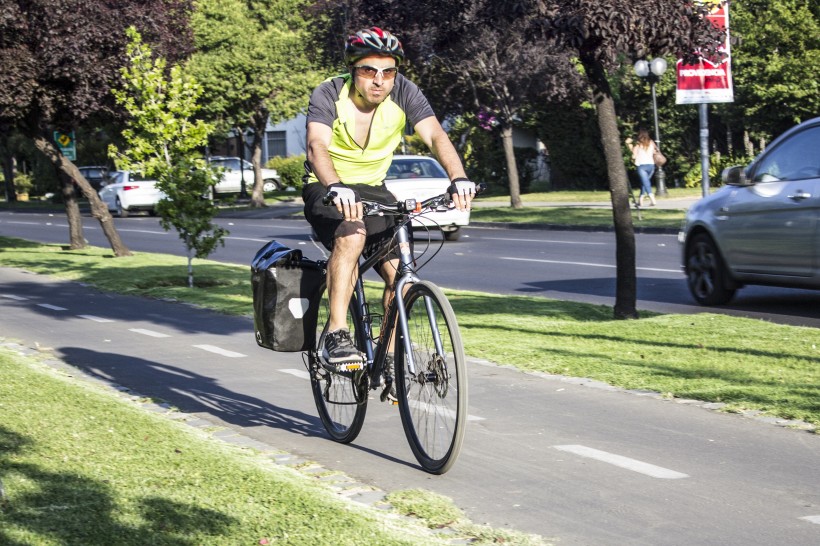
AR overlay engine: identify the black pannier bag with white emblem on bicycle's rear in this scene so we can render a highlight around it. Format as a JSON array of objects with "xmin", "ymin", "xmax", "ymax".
[{"xmin": 251, "ymin": 241, "xmax": 325, "ymax": 352}]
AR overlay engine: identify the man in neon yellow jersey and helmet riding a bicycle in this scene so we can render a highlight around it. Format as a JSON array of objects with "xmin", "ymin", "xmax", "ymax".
[{"xmin": 302, "ymin": 27, "xmax": 475, "ymax": 365}]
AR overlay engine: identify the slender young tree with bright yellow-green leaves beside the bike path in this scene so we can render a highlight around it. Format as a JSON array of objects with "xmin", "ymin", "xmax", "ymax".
[{"xmin": 111, "ymin": 27, "xmax": 227, "ymax": 287}]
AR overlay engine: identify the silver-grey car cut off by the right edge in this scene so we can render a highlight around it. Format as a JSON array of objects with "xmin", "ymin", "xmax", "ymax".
[{"xmin": 680, "ymin": 117, "xmax": 820, "ymax": 305}]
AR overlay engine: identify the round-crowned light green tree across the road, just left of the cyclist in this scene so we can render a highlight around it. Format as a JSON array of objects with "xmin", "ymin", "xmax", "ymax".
[{"xmin": 189, "ymin": 0, "xmax": 321, "ymax": 206}]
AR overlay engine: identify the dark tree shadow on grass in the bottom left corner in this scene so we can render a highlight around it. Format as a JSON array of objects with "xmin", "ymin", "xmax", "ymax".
[{"xmin": 0, "ymin": 425, "xmax": 237, "ymax": 546}]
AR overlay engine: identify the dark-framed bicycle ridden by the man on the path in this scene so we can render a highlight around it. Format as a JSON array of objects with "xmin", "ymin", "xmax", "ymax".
[{"xmin": 306, "ymin": 187, "xmax": 474, "ymax": 474}]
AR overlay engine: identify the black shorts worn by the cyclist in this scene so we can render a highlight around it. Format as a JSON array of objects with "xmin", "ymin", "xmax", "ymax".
[{"xmin": 302, "ymin": 182, "xmax": 398, "ymax": 258}]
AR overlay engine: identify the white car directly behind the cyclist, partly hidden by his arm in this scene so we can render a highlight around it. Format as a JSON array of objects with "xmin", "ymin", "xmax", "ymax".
[{"xmin": 384, "ymin": 155, "xmax": 470, "ymax": 241}]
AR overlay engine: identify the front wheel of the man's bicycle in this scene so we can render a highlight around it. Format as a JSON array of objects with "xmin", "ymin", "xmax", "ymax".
[{"xmin": 395, "ymin": 281, "xmax": 467, "ymax": 474}]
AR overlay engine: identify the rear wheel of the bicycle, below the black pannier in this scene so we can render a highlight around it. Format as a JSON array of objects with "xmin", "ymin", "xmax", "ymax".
[{"xmin": 309, "ymin": 287, "xmax": 370, "ymax": 444}]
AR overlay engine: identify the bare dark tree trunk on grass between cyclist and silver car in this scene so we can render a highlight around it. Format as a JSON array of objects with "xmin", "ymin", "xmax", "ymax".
[{"xmin": 582, "ymin": 58, "xmax": 638, "ymax": 319}]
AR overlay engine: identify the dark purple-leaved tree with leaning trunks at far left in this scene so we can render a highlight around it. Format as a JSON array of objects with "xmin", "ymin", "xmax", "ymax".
[{"xmin": 0, "ymin": 0, "xmax": 191, "ymax": 256}]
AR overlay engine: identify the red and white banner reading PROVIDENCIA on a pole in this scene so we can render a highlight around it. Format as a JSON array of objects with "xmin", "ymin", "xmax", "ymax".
[{"xmin": 675, "ymin": 2, "xmax": 735, "ymax": 104}]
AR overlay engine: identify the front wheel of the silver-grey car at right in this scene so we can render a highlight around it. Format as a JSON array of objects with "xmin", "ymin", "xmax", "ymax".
[{"xmin": 686, "ymin": 233, "xmax": 735, "ymax": 305}]
